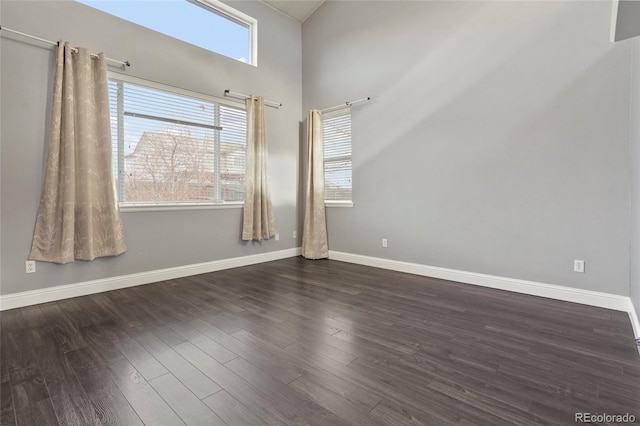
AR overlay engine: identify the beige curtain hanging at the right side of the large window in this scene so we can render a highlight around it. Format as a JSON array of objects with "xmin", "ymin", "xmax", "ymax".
[{"xmin": 242, "ymin": 96, "xmax": 278, "ymax": 241}]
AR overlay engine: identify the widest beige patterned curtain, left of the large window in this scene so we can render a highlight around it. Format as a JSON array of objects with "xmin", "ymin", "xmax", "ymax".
[{"xmin": 29, "ymin": 42, "xmax": 127, "ymax": 263}]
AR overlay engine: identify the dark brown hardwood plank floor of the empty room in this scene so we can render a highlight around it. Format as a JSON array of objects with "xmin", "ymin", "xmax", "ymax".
[{"xmin": 0, "ymin": 258, "xmax": 640, "ymax": 426}]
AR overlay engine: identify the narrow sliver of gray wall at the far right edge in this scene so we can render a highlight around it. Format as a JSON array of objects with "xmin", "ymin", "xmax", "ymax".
[{"xmin": 623, "ymin": 38, "xmax": 640, "ymax": 314}]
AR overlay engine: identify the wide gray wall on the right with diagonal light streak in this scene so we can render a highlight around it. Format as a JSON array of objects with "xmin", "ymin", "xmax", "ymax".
[{"xmin": 302, "ymin": 1, "xmax": 631, "ymax": 296}]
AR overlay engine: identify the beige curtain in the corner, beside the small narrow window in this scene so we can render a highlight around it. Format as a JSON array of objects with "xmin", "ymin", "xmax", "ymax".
[{"xmin": 302, "ymin": 110, "xmax": 329, "ymax": 259}]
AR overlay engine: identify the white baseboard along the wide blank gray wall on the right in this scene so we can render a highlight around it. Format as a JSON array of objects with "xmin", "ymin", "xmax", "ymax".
[{"xmin": 329, "ymin": 250, "xmax": 640, "ymax": 312}]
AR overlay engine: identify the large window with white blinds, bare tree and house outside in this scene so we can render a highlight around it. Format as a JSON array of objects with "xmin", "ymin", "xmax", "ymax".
[{"xmin": 109, "ymin": 74, "xmax": 246, "ymax": 207}]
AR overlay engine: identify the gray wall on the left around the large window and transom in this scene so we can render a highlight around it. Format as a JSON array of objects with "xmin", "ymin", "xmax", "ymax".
[{"xmin": 0, "ymin": 0, "xmax": 302, "ymax": 294}]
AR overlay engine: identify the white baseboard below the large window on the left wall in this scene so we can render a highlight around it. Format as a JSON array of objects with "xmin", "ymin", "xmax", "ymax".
[{"xmin": 0, "ymin": 247, "xmax": 301, "ymax": 311}]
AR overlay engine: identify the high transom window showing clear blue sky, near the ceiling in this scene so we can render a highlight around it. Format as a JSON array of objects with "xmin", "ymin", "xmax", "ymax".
[{"xmin": 77, "ymin": 0, "xmax": 258, "ymax": 65}]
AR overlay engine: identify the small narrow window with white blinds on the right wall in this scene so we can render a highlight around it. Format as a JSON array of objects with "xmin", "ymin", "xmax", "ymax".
[{"xmin": 322, "ymin": 108, "xmax": 352, "ymax": 204}]
